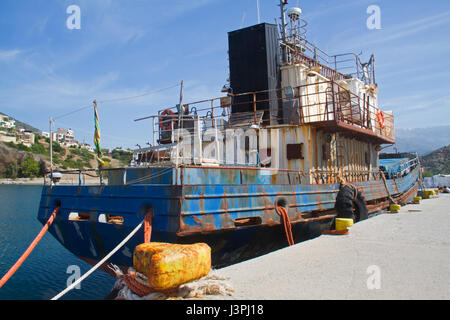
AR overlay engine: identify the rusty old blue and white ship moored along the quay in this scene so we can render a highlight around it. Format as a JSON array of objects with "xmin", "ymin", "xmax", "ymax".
[{"xmin": 38, "ymin": 1, "xmax": 420, "ymax": 268}]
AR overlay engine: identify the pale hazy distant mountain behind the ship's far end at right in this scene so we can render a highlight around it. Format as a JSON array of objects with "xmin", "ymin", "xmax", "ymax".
[{"xmin": 383, "ymin": 126, "xmax": 450, "ymax": 155}]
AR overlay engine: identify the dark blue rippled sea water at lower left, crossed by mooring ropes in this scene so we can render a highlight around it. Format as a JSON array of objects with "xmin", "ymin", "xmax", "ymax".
[{"xmin": 0, "ymin": 185, "xmax": 115, "ymax": 300}]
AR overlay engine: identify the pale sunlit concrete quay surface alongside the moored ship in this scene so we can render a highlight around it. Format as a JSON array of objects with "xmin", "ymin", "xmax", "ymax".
[{"xmin": 219, "ymin": 194, "xmax": 450, "ymax": 300}]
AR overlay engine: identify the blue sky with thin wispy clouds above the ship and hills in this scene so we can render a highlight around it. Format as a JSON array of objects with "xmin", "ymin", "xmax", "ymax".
[{"xmin": 0, "ymin": 0, "xmax": 450, "ymax": 147}]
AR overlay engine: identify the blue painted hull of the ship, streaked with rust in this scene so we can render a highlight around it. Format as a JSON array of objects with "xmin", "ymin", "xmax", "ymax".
[{"xmin": 38, "ymin": 167, "xmax": 419, "ymax": 268}]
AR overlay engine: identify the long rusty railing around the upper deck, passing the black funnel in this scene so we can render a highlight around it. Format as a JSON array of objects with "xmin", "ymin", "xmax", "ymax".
[{"xmin": 153, "ymin": 80, "xmax": 395, "ymax": 151}]
